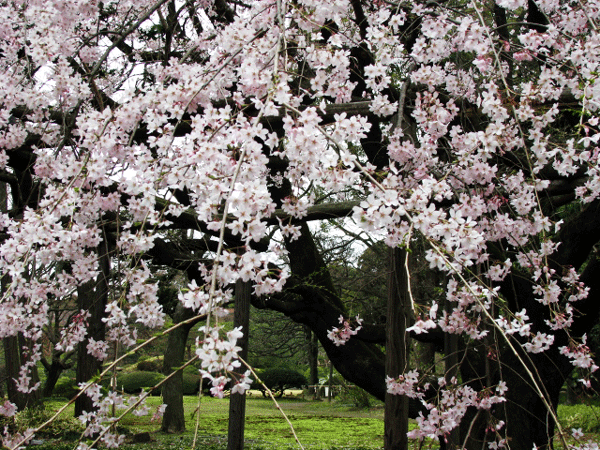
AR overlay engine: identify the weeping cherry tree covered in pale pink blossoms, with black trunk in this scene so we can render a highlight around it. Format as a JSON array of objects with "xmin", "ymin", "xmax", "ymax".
[{"xmin": 0, "ymin": 0, "xmax": 600, "ymax": 448}]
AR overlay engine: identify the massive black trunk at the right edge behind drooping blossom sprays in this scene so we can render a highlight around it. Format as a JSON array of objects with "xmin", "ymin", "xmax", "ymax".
[{"xmin": 460, "ymin": 201, "xmax": 600, "ymax": 449}]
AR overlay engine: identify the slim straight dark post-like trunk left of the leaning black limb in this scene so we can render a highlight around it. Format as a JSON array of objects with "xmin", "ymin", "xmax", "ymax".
[{"xmin": 227, "ymin": 280, "xmax": 252, "ymax": 450}]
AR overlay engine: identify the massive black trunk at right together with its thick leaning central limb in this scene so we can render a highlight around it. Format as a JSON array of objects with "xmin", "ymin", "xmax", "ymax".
[{"xmin": 256, "ymin": 197, "xmax": 600, "ymax": 448}]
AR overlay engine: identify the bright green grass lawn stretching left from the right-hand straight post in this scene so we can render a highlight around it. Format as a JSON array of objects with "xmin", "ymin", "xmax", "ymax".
[{"xmin": 38, "ymin": 394, "xmax": 390, "ymax": 450}]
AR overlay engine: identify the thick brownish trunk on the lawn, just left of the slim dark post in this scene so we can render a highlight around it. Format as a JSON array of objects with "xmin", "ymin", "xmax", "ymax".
[{"xmin": 161, "ymin": 303, "xmax": 197, "ymax": 433}]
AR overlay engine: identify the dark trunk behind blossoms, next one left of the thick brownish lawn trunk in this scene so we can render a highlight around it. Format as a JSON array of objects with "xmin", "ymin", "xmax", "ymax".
[{"xmin": 75, "ymin": 239, "xmax": 110, "ymax": 417}]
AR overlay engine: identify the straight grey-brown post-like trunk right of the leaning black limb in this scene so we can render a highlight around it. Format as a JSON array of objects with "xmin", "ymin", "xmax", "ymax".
[{"xmin": 384, "ymin": 248, "xmax": 410, "ymax": 450}]
